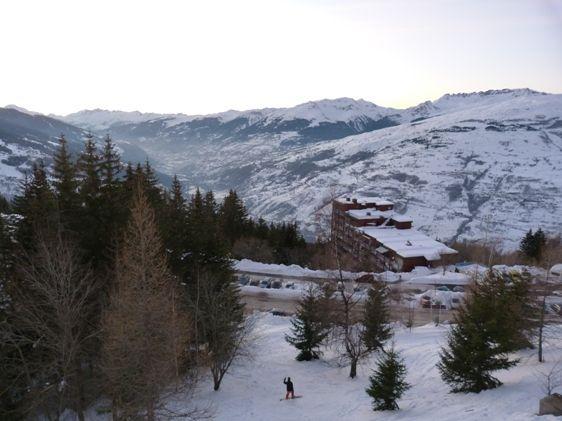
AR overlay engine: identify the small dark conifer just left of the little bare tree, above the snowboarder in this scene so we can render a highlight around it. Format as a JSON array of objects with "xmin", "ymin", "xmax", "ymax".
[{"xmin": 285, "ymin": 287, "xmax": 329, "ymax": 361}]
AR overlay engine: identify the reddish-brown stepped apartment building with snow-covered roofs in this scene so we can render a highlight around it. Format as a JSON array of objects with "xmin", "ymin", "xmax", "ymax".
[{"xmin": 332, "ymin": 196, "xmax": 457, "ymax": 272}]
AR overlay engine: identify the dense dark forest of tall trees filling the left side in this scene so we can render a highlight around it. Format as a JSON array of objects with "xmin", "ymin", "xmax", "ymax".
[{"xmin": 0, "ymin": 135, "xmax": 305, "ymax": 420}]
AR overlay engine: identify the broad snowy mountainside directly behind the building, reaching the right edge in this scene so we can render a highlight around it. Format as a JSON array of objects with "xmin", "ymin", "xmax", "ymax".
[{"xmin": 243, "ymin": 88, "xmax": 562, "ymax": 247}]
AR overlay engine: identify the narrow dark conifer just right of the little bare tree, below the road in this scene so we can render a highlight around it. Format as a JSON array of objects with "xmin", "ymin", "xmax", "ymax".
[{"xmin": 363, "ymin": 282, "xmax": 392, "ymax": 351}]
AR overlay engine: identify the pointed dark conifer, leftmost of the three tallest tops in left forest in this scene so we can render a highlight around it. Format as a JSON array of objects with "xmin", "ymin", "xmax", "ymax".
[{"xmin": 53, "ymin": 134, "xmax": 80, "ymax": 225}]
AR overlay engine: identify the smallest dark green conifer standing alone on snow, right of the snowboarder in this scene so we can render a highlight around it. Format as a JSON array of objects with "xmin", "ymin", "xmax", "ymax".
[{"xmin": 366, "ymin": 348, "xmax": 410, "ymax": 411}]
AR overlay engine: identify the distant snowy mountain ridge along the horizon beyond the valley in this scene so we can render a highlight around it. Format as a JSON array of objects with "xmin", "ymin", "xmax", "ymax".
[{"xmin": 55, "ymin": 98, "xmax": 403, "ymax": 142}]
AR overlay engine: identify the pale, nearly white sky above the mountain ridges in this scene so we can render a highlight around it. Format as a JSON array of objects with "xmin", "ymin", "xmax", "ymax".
[{"xmin": 0, "ymin": 0, "xmax": 562, "ymax": 114}]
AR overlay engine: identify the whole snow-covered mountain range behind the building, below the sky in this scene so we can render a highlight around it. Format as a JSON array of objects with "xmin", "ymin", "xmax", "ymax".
[{"xmin": 0, "ymin": 89, "xmax": 562, "ymax": 247}]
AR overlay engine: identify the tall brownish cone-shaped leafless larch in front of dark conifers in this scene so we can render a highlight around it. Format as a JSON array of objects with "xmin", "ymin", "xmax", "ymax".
[{"xmin": 102, "ymin": 189, "xmax": 200, "ymax": 420}]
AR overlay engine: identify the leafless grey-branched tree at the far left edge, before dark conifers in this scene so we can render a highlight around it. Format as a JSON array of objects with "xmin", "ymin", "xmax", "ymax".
[{"xmin": 2, "ymin": 233, "xmax": 96, "ymax": 420}]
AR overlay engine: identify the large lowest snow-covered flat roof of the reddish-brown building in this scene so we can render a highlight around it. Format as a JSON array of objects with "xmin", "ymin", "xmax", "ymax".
[{"xmin": 358, "ymin": 226, "xmax": 457, "ymax": 261}]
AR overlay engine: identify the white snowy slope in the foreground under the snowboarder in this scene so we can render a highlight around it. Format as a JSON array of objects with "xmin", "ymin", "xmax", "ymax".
[{"xmin": 168, "ymin": 314, "xmax": 562, "ymax": 421}]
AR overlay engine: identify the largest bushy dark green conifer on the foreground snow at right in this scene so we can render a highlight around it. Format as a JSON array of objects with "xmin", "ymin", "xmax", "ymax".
[{"xmin": 437, "ymin": 271, "xmax": 521, "ymax": 393}]
